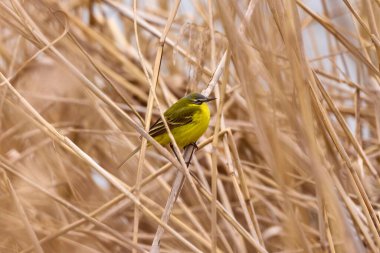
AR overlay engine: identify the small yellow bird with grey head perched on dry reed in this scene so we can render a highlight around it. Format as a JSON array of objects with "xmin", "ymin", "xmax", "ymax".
[{"xmin": 123, "ymin": 93, "xmax": 215, "ymax": 164}]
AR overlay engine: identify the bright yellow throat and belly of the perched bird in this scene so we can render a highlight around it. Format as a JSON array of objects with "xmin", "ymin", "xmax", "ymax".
[{"xmin": 154, "ymin": 103, "xmax": 210, "ymax": 148}]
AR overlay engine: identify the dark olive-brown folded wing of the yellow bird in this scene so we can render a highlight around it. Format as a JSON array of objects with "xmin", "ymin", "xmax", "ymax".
[{"xmin": 149, "ymin": 106, "xmax": 198, "ymax": 137}]
